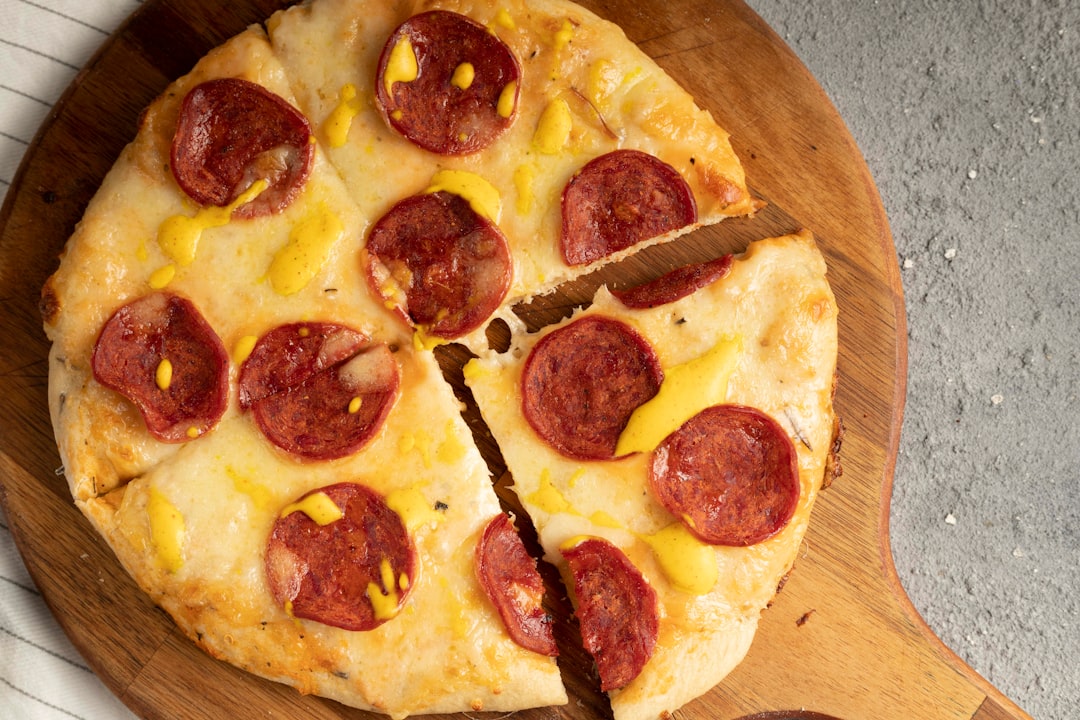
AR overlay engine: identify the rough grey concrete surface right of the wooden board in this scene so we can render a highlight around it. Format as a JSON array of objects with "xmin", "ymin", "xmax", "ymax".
[{"xmin": 750, "ymin": 0, "xmax": 1080, "ymax": 720}]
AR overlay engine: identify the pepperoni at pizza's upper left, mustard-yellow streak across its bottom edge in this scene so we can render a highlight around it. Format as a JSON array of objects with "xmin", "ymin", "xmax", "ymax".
[{"xmin": 172, "ymin": 78, "xmax": 314, "ymax": 218}]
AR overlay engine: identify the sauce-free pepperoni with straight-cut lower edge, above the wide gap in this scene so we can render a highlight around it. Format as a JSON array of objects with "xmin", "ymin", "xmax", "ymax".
[{"xmin": 559, "ymin": 150, "xmax": 698, "ymax": 266}]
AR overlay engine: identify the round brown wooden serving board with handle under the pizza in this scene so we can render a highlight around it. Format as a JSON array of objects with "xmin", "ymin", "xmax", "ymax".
[{"xmin": 0, "ymin": 0, "xmax": 1028, "ymax": 720}]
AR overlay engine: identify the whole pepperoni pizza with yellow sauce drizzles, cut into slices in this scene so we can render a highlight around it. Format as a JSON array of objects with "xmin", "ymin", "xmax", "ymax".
[{"xmin": 41, "ymin": 0, "xmax": 838, "ymax": 720}]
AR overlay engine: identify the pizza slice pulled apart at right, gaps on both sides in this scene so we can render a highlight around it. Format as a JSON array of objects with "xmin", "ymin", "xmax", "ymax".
[{"xmin": 465, "ymin": 232, "xmax": 839, "ymax": 720}]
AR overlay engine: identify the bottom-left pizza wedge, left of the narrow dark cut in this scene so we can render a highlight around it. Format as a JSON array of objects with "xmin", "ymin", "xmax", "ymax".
[{"xmin": 80, "ymin": 345, "xmax": 566, "ymax": 718}]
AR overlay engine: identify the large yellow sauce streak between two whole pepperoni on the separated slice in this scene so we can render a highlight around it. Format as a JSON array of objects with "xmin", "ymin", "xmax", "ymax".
[{"xmin": 615, "ymin": 337, "xmax": 742, "ymax": 456}]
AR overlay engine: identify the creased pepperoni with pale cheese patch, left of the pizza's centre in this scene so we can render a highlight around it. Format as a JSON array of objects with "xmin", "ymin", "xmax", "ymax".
[{"xmin": 240, "ymin": 323, "xmax": 401, "ymax": 460}]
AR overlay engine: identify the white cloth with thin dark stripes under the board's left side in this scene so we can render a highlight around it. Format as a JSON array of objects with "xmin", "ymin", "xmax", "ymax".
[{"xmin": 0, "ymin": 0, "xmax": 139, "ymax": 720}]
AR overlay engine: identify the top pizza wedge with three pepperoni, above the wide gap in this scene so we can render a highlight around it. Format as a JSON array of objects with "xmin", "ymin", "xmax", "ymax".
[{"xmin": 268, "ymin": 0, "xmax": 759, "ymax": 350}]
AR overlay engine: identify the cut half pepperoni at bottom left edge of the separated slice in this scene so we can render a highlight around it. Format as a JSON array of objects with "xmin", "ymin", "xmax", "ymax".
[{"xmin": 562, "ymin": 538, "xmax": 660, "ymax": 692}]
